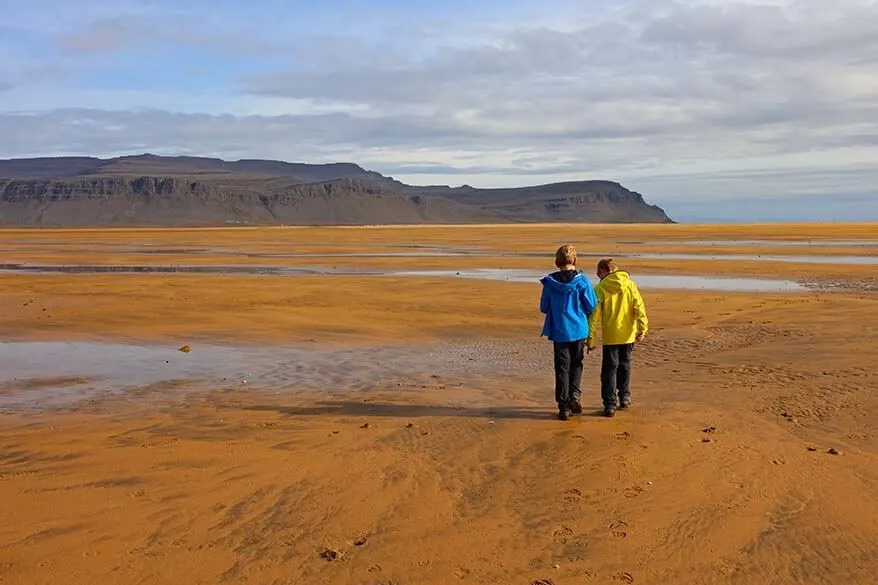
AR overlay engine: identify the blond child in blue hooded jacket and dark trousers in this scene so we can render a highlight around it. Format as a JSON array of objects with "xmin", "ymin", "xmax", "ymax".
[{"xmin": 540, "ymin": 245, "xmax": 598, "ymax": 420}]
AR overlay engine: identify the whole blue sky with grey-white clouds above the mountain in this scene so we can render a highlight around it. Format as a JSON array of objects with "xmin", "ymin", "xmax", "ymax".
[{"xmin": 0, "ymin": 0, "xmax": 878, "ymax": 220}]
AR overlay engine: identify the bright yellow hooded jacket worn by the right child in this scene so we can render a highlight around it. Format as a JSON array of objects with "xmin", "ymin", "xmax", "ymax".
[{"xmin": 586, "ymin": 270, "xmax": 649, "ymax": 348}]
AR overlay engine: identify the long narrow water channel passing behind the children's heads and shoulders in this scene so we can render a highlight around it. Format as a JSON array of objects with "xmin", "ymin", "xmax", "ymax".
[{"xmin": 0, "ymin": 264, "xmax": 809, "ymax": 292}]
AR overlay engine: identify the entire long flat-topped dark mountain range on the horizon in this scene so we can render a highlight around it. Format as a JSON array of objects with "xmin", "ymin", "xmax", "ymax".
[{"xmin": 0, "ymin": 155, "xmax": 671, "ymax": 227}]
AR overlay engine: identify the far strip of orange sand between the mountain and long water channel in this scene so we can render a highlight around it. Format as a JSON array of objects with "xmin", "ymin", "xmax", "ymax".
[{"xmin": 0, "ymin": 224, "xmax": 878, "ymax": 285}]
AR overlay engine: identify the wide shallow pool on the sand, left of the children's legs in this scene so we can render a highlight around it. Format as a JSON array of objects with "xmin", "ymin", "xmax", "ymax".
[{"xmin": 0, "ymin": 340, "xmax": 551, "ymax": 411}]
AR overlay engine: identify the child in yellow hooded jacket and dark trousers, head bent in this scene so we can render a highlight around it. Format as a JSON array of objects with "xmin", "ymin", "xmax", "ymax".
[{"xmin": 586, "ymin": 258, "xmax": 649, "ymax": 416}]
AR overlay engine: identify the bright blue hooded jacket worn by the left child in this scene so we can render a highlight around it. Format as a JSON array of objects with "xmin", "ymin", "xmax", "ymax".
[{"xmin": 540, "ymin": 270, "xmax": 598, "ymax": 342}]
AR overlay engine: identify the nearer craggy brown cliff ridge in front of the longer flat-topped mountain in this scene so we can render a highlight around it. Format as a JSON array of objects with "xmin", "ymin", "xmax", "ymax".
[{"xmin": 0, "ymin": 177, "xmax": 489, "ymax": 226}]
